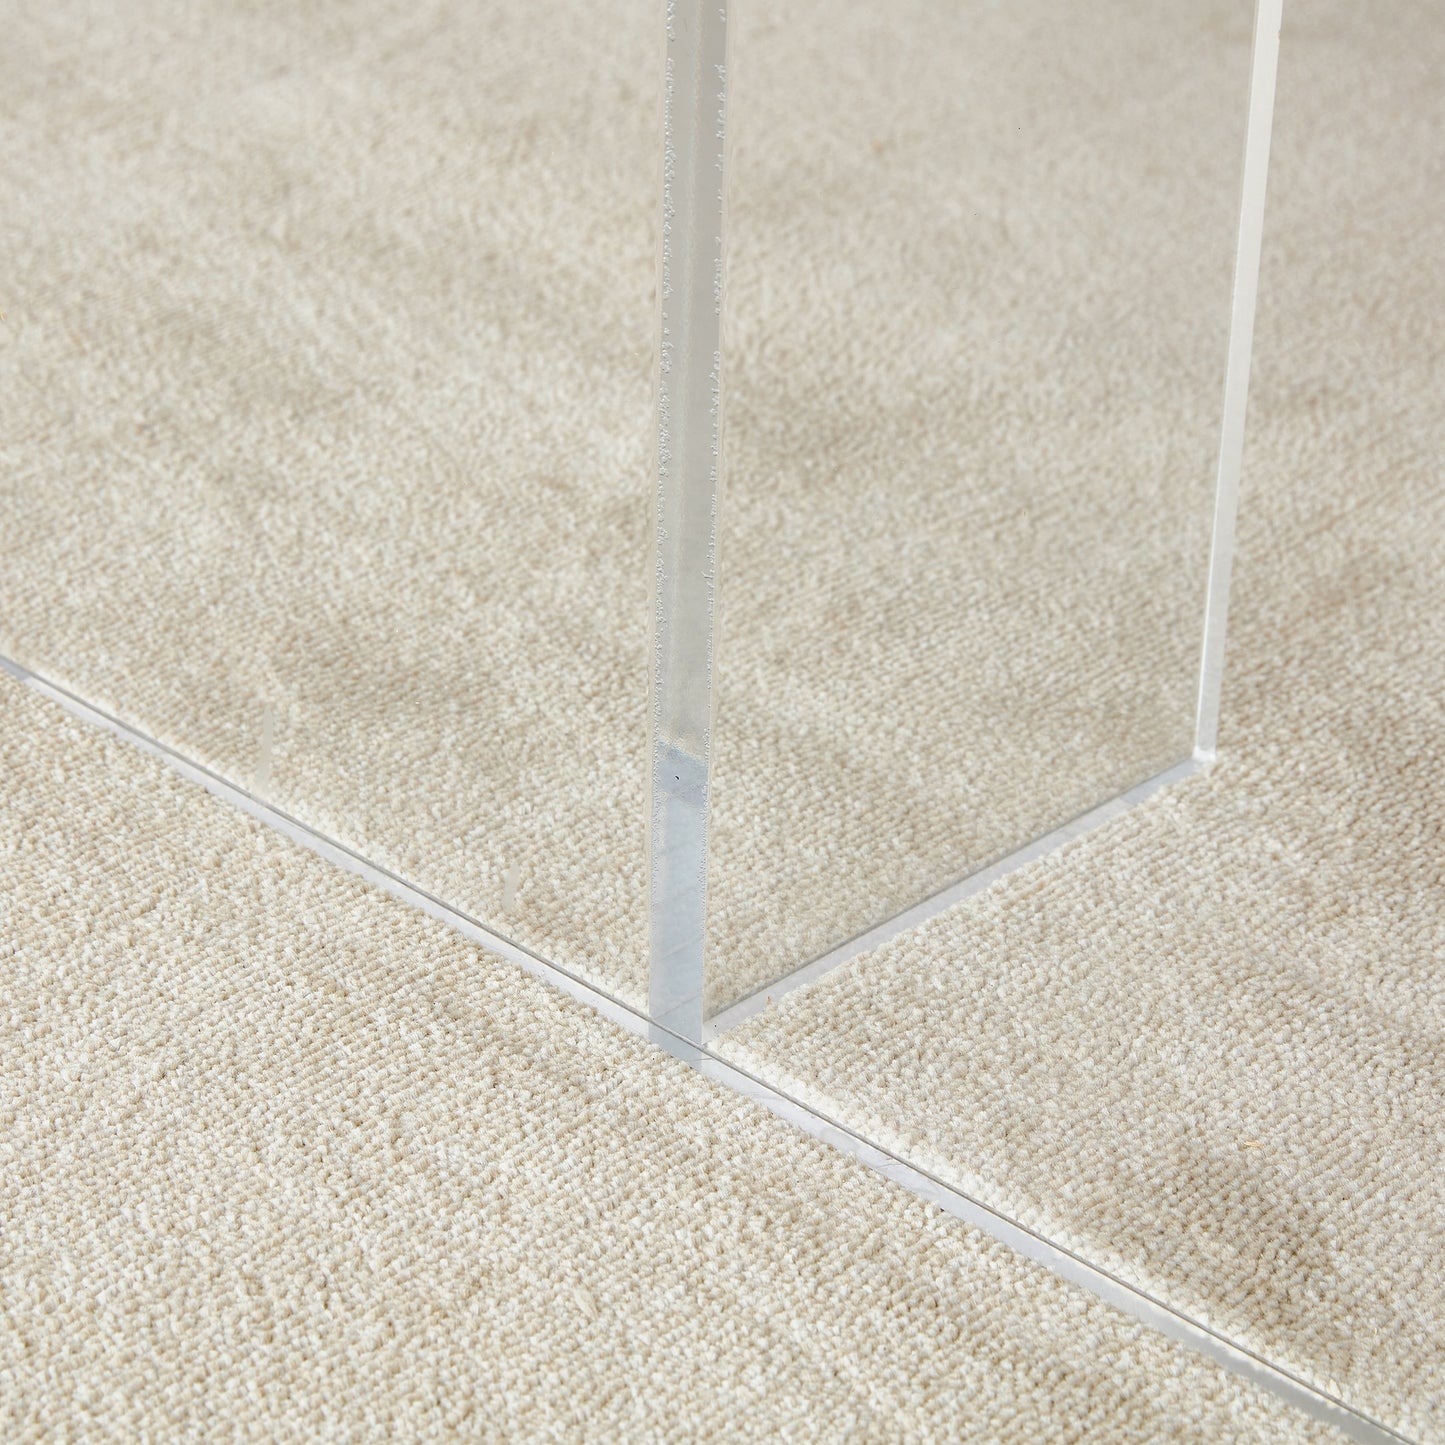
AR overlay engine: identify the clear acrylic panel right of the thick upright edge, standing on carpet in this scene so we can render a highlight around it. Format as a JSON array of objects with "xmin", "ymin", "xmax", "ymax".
[{"xmin": 707, "ymin": 0, "xmax": 1253, "ymax": 1012}]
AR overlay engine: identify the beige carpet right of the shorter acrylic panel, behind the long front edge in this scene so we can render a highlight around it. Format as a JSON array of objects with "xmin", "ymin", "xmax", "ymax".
[{"xmin": 724, "ymin": 4, "xmax": 1445, "ymax": 1441}]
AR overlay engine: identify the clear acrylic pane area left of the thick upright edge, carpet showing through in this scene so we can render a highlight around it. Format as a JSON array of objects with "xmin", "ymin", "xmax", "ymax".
[{"xmin": 0, "ymin": 0, "xmax": 662, "ymax": 1001}]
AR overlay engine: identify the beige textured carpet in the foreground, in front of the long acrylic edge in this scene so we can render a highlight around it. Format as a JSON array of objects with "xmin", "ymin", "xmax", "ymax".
[{"xmin": 0, "ymin": 679, "xmax": 1337, "ymax": 1445}]
